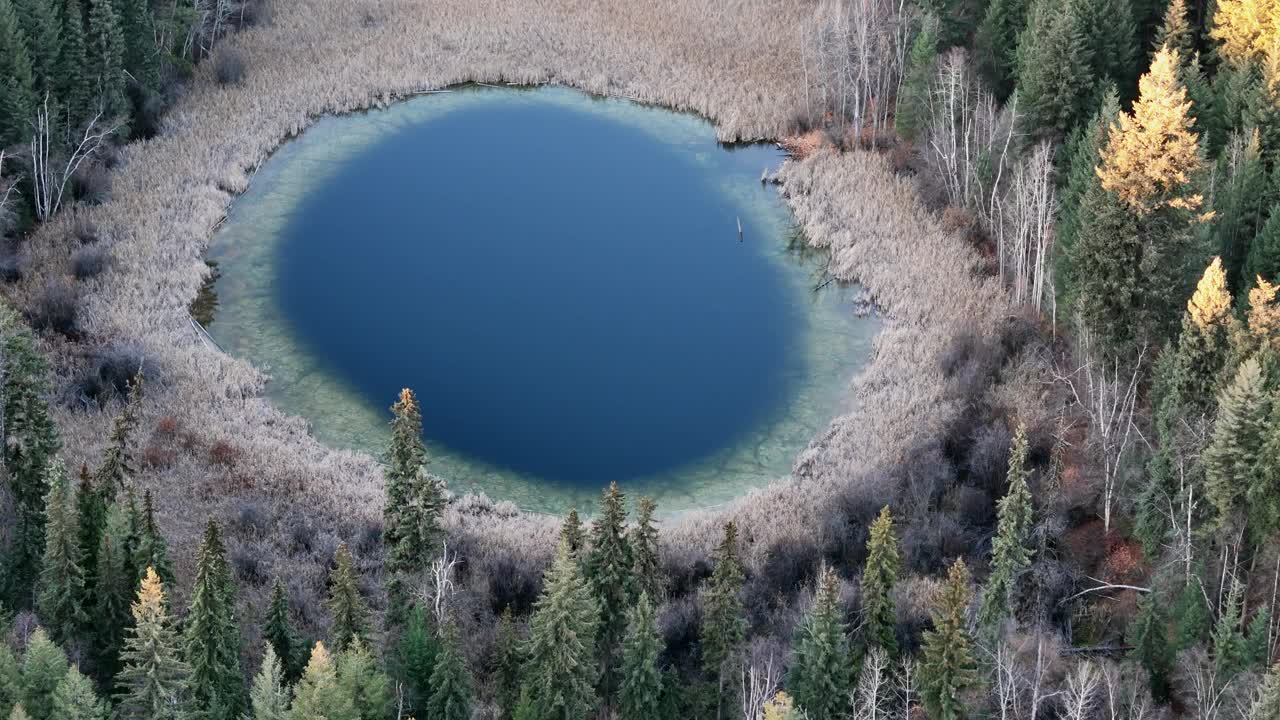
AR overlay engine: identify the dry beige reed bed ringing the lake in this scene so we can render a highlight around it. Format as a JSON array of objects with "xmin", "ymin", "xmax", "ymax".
[{"xmin": 12, "ymin": 0, "xmax": 1006, "ymax": 609}]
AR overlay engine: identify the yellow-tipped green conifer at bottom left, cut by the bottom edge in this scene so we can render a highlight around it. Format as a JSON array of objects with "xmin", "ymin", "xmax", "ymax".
[{"xmin": 115, "ymin": 568, "xmax": 191, "ymax": 720}]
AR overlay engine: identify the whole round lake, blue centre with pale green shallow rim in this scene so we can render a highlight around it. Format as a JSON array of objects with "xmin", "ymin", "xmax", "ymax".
[{"xmin": 209, "ymin": 88, "xmax": 876, "ymax": 511}]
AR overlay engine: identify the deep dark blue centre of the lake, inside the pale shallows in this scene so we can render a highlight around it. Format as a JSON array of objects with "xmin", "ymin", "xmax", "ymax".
[{"xmin": 275, "ymin": 98, "xmax": 806, "ymax": 487}]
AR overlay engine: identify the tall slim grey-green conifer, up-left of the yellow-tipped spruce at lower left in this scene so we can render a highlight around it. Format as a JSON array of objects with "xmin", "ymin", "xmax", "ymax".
[{"xmin": 37, "ymin": 459, "xmax": 88, "ymax": 642}]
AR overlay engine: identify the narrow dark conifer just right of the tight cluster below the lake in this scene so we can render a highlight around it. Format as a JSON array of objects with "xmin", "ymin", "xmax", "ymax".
[{"xmin": 699, "ymin": 521, "xmax": 746, "ymax": 715}]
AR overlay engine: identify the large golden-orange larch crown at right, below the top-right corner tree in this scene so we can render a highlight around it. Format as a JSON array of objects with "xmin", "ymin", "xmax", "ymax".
[{"xmin": 1097, "ymin": 47, "xmax": 1203, "ymax": 217}]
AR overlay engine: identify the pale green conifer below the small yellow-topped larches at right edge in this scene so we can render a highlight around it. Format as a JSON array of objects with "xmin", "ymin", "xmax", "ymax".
[{"xmin": 1203, "ymin": 357, "xmax": 1270, "ymax": 527}]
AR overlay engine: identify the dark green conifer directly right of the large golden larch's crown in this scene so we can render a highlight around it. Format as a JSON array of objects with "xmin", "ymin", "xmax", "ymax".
[{"xmin": 1210, "ymin": 129, "xmax": 1272, "ymax": 292}]
